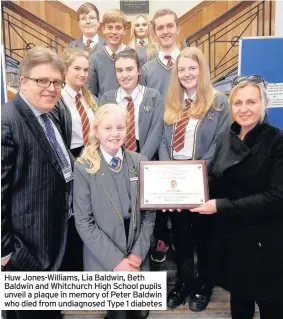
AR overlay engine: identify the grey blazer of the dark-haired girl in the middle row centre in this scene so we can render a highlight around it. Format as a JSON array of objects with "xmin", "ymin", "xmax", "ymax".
[{"xmin": 99, "ymin": 87, "xmax": 164, "ymax": 160}]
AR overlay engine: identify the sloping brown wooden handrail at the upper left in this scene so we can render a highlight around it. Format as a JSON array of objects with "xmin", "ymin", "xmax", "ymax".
[{"xmin": 1, "ymin": 1, "xmax": 74, "ymax": 43}]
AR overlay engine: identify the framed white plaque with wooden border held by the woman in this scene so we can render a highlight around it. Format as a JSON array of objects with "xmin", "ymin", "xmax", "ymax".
[{"xmin": 139, "ymin": 160, "xmax": 209, "ymax": 210}]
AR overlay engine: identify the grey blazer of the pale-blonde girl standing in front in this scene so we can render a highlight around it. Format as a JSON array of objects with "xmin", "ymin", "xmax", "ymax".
[{"xmin": 73, "ymin": 151, "xmax": 155, "ymax": 271}]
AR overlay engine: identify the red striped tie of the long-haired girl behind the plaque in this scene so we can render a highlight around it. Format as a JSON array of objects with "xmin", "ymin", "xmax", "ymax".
[{"xmin": 173, "ymin": 99, "xmax": 192, "ymax": 152}]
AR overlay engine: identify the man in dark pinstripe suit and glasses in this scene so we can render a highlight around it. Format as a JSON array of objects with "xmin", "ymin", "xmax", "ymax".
[{"xmin": 1, "ymin": 47, "xmax": 73, "ymax": 319}]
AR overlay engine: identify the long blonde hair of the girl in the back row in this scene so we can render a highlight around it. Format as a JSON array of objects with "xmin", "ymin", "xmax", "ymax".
[{"xmin": 128, "ymin": 14, "xmax": 157, "ymax": 61}]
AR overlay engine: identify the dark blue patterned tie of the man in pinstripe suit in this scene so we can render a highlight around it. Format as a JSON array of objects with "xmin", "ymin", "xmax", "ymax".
[{"xmin": 41, "ymin": 114, "xmax": 70, "ymax": 169}]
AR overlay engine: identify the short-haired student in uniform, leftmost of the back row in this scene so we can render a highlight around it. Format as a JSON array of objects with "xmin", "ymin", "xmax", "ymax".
[{"xmin": 68, "ymin": 2, "xmax": 106, "ymax": 53}]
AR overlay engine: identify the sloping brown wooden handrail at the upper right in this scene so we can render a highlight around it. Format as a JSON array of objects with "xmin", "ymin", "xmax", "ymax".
[{"xmin": 185, "ymin": 0, "xmax": 257, "ymax": 46}]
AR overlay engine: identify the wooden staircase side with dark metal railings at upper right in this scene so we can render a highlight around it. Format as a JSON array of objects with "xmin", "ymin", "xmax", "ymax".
[{"xmin": 185, "ymin": 1, "xmax": 275, "ymax": 87}]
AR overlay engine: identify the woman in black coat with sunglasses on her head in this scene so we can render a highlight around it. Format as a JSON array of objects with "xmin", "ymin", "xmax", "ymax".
[{"xmin": 194, "ymin": 75, "xmax": 283, "ymax": 319}]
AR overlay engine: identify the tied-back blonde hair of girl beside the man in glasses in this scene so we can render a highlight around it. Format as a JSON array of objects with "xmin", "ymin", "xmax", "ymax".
[{"xmin": 61, "ymin": 48, "xmax": 98, "ymax": 112}]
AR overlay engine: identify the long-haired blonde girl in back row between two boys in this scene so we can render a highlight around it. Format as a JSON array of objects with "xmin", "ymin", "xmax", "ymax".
[{"xmin": 128, "ymin": 14, "xmax": 157, "ymax": 66}]
